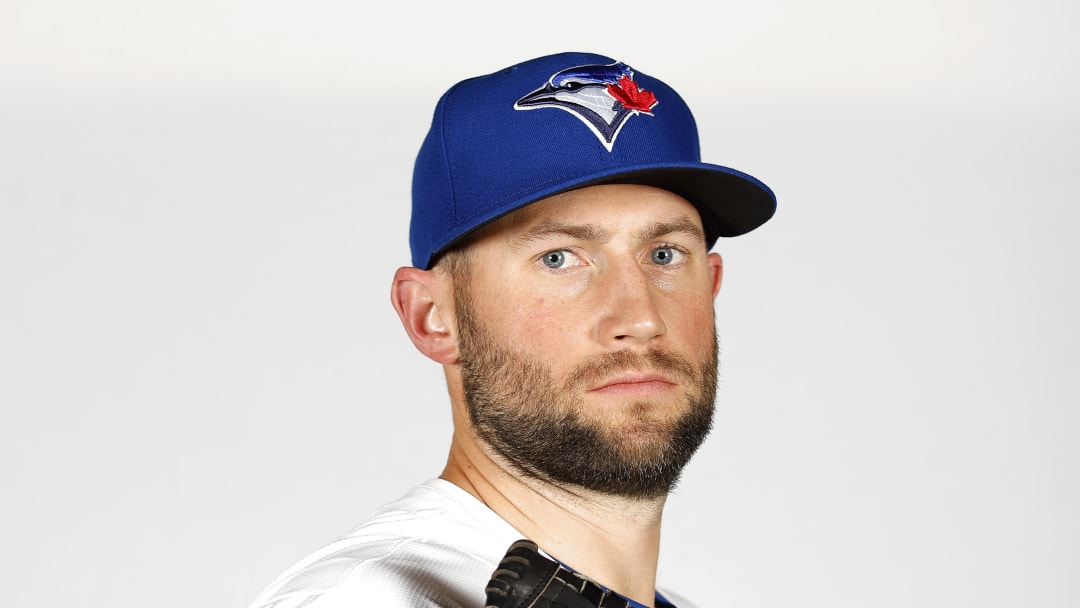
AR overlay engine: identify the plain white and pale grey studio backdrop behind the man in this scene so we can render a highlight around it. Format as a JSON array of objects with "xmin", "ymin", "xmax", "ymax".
[{"xmin": 0, "ymin": 0, "xmax": 1080, "ymax": 608}]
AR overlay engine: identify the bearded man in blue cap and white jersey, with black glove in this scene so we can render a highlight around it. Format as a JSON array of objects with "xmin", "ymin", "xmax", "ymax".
[{"xmin": 254, "ymin": 53, "xmax": 775, "ymax": 608}]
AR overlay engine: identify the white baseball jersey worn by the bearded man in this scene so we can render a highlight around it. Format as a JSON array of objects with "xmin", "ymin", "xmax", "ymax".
[{"xmin": 251, "ymin": 479, "xmax": 689, "ymax": 608}]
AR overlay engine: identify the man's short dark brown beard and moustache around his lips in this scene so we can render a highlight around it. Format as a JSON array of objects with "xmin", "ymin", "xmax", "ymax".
[{"xmin": 455, "ymin": 288, "xmax": 717, "ymax": 499}]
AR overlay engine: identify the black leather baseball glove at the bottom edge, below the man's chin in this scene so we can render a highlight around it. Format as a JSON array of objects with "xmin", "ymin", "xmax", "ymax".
[{"xmin": 484, "ymin": 540, "xmax": 630, "ymax": 608}]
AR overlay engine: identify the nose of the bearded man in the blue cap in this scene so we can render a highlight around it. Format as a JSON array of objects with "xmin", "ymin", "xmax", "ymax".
[{"xmin": 598, "ymin": 260, "xmax": 667, "ymax": 346}]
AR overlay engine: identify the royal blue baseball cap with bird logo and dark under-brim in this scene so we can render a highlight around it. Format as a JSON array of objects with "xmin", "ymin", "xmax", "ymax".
[{"xmin": 409, "ymin": 53, "xmax": 777, "ymax": 269}]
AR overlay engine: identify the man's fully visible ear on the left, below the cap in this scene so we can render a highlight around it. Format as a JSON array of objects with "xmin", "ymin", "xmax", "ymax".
[{"xmin": 390, "ymin": 266, "xmax": 458, "ymax": 364}]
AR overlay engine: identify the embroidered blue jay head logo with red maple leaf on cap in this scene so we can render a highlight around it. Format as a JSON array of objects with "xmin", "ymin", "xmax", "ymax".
[{"xmin": 514, "ymin": 62, "xmax": 657, "ymax": 152}]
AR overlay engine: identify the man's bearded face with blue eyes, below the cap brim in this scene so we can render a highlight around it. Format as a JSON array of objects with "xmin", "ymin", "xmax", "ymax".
[{"xmin": 455, "ymin": 185, "xmax": 720, "ymax": 498}]
